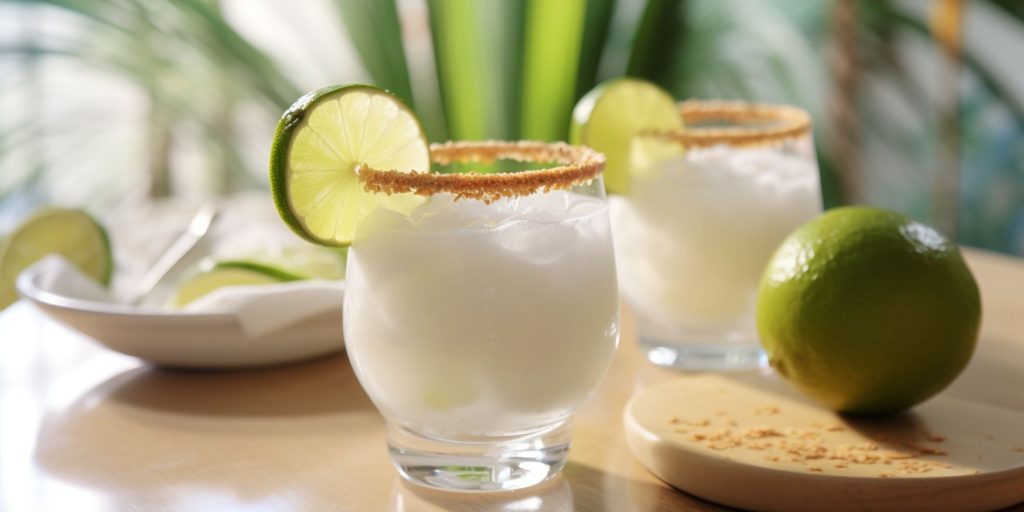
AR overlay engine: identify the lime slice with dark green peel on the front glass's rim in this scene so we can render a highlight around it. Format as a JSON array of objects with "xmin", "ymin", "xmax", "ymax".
[{"xmin": 270, "ymin": 85, "xmax": 430, "ymax": 247}]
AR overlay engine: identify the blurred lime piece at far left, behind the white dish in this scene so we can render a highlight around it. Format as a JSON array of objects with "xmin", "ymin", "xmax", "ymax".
[{"xmin": 0, "ymin": 208, "xmax": 114, "ymax": 309}]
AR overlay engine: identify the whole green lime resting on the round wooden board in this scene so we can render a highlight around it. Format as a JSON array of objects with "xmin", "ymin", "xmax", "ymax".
[{"xmin": 757, "ymin": 207, "xmax": 981, "ymax": 414}]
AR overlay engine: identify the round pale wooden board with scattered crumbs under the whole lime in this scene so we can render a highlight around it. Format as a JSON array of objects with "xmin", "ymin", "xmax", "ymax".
[{"xmin": 624, "ymin": 374, "xmax": 1024, "ymax": 512}]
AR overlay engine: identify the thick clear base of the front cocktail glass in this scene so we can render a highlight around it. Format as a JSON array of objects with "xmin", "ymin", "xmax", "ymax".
[{"xmin": 388, "ymin": 421, "xmax": 569, "ymax": 493}]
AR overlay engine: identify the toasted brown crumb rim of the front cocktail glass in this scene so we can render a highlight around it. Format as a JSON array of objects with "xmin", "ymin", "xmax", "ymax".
[{"xmin": 356, "ymin": 140, "xmax": 604, "ymax": 203}]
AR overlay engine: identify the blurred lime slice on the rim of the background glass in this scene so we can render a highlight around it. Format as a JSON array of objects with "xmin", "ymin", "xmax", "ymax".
[{"xmin": 569, "ymin": 78, "xmax": 683, "ymax": 194}]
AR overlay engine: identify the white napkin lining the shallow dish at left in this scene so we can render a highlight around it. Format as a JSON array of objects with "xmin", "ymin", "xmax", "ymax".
[{"xmin": 23, "ymin": 255, "xmax": 345, "ymax": 338}]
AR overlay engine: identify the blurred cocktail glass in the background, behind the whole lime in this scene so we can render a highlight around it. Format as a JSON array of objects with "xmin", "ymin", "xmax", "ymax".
[{"xmin": 610, "ymin": 100, "xmax": 821, "ymax": 370}]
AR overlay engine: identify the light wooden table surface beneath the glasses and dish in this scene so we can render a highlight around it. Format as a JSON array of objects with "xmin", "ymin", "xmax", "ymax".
[{"xmin": 0, "ymin": 251, "xmax": 1024, "ymax": 512}]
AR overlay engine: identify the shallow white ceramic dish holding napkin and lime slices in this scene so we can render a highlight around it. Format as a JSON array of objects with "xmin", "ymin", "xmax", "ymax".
[{"xmin": 17, "ymin": 260, "xmax": 344, "ymax": 369}]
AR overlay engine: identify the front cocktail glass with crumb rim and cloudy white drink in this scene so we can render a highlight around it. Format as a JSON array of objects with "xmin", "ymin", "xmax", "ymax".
[{"xmin": 344, "ymin": 142, "xmax": 618, "ymax": 490}]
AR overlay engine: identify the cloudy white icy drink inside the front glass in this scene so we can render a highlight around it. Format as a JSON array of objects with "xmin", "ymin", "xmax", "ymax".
[{"xmin": 346, "ymin": 190, "xmax": 617, "ymax": 437}]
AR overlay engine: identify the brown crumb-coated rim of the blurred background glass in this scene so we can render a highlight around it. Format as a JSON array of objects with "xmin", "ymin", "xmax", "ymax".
[{"xmin": 640, "ymin": 99, "xmax": 811, "ymax": 147}]
